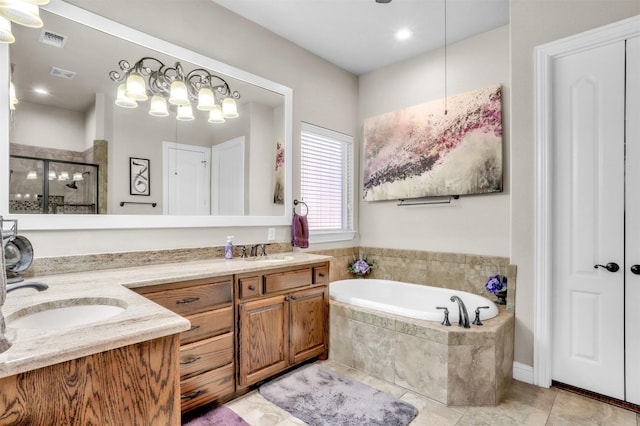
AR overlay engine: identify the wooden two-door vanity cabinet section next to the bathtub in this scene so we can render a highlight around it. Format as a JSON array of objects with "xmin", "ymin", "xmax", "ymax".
[{"xmin": 236, "ymin": 263, "xmax": 329, "ymax": 388}]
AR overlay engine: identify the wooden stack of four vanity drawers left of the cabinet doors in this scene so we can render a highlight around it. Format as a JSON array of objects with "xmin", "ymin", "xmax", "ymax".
[{"xmin": 136, "ymin": 276, "xmax": 235, "ymax": 412}]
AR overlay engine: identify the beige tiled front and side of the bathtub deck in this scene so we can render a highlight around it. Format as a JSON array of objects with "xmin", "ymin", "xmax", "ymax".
[{"xmin": 329, "ymin": 300, "xmax": 514, "ymax": 406}]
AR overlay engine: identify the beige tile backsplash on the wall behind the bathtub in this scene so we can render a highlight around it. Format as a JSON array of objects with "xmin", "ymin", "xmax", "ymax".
[{"xmin": 311, "ymin": 247, "xmax": 517, "ymax": 313}]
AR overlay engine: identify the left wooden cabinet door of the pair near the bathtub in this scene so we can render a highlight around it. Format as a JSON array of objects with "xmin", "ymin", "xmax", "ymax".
[{"xmin": 238, "ymin": 296, "xmax": 289, "ymax": 387}]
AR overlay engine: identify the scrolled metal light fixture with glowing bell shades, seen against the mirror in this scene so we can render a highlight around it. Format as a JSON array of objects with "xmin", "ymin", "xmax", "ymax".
[{"xmin": 109, "ymin": 57, "xmax": 240, "ymax": 123}]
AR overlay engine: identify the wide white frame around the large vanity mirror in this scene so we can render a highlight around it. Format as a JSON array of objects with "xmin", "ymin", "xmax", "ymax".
[{"xmin": 0, "ymin": 0, "xmax": 293, "ymax": 230}]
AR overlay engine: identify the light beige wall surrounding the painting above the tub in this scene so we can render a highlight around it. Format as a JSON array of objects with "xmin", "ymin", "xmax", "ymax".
[{"xmin": 359, "ymin": 26, "xmax": 510, "ymax": 256}]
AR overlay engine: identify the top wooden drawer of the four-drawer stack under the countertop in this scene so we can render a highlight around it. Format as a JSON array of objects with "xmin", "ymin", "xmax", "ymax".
[{"xmin": 145, "ymin": 281, "xmax": 233, "ymax": 315}]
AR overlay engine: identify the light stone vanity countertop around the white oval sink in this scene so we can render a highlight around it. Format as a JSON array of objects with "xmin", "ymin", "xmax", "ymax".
[{"xmin": 0, "ymin": 252, "xmax": 330, "ymax": 378}]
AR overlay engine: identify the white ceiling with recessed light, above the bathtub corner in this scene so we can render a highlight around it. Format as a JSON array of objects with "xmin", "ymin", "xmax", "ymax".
[{"xmin": 212, "ymin": 0, "xmax": 509, "ymax": 75}]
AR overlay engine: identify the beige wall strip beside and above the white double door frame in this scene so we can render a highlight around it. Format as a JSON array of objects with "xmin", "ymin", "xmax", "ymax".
[{"xmin": 511, "ymin": 0, "xmax": 640, "ymax": 365}]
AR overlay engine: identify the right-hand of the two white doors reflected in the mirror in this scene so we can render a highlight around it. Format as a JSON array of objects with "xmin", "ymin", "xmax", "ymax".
[{"xmin": 211, "ymin": 136, "xmax": 245, "ymax": 216}]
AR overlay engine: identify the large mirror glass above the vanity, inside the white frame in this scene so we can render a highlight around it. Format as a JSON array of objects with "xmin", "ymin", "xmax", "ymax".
[{"xmin": 4, "ymin": 5, "xmax": 291, "ymax": 225}]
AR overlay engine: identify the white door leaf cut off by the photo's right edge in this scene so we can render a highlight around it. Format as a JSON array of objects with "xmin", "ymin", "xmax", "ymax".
[{"xmin": 625, "ymin": 37, "xmax": 640, "ymax": 404}]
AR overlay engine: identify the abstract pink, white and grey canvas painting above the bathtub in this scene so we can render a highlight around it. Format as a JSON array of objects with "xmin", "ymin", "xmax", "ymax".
[{"xmin": 363, "ymin": 85, "xmax": 502, "ymax": 201}]
